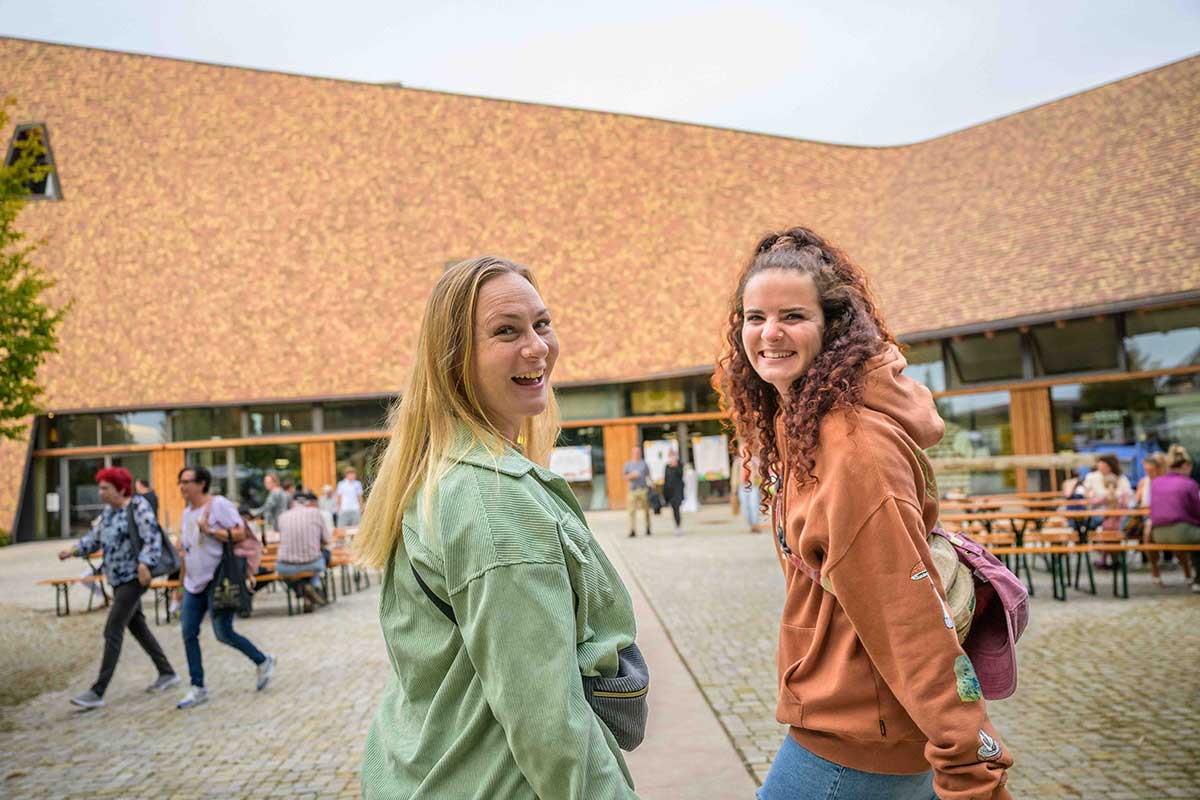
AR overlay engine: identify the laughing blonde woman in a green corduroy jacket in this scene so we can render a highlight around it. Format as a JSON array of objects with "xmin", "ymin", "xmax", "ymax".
[{"xmin": 355, "ymin": 257, "xmax": 636, "ymax": 799}]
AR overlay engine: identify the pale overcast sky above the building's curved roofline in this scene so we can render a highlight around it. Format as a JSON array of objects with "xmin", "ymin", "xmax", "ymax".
[{"xmin": 0, "ymin": 0, "xmax": 1200, "ymax": 145}]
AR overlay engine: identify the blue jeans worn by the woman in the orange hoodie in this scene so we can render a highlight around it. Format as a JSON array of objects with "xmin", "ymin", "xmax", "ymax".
[{"xmin": 755, "ymin": 736, "xmax": 937, "ymax": 800}]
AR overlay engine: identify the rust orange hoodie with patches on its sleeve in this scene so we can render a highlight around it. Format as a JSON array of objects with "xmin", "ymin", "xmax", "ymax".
[{"xmin": 775, "ymin": 347, "xmax": 1013, "ymax": 800}]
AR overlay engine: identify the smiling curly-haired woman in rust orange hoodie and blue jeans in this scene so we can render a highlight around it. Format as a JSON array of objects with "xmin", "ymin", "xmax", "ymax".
[{"xmin": 718, "ymin": 228, "xmax": 1013, "ymax": 800}]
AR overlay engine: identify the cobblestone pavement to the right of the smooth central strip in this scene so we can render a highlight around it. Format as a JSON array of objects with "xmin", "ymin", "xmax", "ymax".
[{"xmin": 592, "ymin": 507, "xmax": 1200, "ymax": 800}]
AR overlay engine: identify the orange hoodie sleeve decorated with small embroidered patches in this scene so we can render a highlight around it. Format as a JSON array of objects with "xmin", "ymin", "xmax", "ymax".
[{"xmin": 824, "ymin": 495, "xmax": 1013, "ymax": 800}]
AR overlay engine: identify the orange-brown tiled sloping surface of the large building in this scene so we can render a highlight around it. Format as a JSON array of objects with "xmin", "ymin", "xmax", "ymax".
[{"xmin": 0, "ymin": 38, "xmax": 1200, "ymax": 534}]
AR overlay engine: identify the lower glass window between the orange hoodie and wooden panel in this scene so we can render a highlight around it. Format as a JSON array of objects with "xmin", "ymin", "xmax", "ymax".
[{"xmin": 928, "ymin": 392, "xmax": 1016, "ymax": 495}]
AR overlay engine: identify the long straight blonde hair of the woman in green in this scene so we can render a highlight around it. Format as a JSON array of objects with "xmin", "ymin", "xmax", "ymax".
[{"xmin": 354, "ymin": 255, "xmax": 559, "ymax": 569}]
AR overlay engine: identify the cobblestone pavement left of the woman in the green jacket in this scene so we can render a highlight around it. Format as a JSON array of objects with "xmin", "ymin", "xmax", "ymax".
[{"xmin": 0, "ymin": 542, "xmax": 389, "ymax": 798}]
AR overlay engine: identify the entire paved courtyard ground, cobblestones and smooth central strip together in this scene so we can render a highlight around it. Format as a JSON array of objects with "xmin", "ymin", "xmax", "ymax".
[{"xmin": 0, "ymin": 509, "xmax": 1200, "ymax": 800}]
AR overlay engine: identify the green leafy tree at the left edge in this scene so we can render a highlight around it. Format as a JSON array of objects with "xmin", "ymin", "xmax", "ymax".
[{"xmin": 0, "ymin": 97, "xmax": 70, "ymax": 439}]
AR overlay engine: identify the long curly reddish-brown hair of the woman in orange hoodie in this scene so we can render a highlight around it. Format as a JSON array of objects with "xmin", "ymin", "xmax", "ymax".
[{"xmin": 713, "ymin": 228, "xmax": 895, "ymax": 503}]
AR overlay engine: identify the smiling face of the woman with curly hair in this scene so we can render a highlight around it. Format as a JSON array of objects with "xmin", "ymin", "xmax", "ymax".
[{"xmin": 742, "ymin": 270, "xmax": 824, "ymax": 397}]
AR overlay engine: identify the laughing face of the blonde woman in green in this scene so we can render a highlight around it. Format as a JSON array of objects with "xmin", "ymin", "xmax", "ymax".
[{"xmin": 470, "ymin": 272, "xmax": 558, "ymax": 441}]
